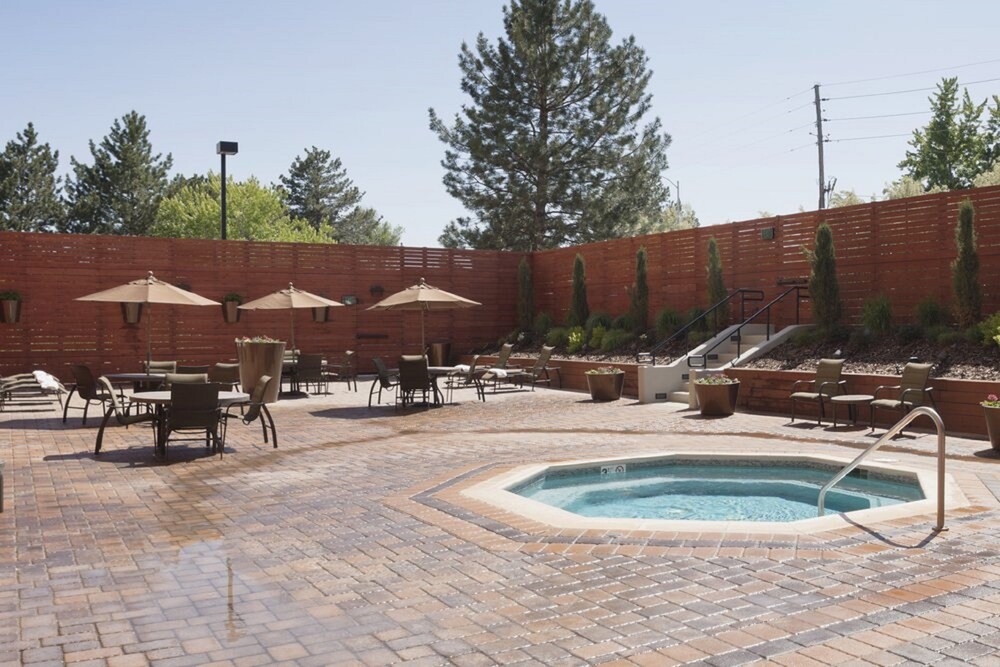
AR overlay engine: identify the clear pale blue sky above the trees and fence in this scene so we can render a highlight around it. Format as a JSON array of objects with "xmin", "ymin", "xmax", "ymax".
[{"xmin": 0, "ymin": 0, "xmax": 1000, "ymax": 246}]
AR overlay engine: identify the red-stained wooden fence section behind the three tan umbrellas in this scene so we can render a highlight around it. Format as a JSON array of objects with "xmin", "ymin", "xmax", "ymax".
[{"xmin": 0, "ymin": 232, "xmax": 520, "ymax": 379}]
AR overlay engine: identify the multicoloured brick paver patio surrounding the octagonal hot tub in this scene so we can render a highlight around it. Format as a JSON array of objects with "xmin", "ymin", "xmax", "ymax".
[{"xmin": 0, "ymin": 385, "xmax": 1000, "ymax": 667}]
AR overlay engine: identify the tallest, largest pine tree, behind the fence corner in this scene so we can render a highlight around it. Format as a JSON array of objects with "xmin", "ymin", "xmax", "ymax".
[{"xmin": 430, "ymin": 0, "xmax": 670, "ymax": 251}]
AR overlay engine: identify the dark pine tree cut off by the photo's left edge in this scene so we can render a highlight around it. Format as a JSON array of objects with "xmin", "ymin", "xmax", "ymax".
[{"xmin": 0, "ymin": 123, "xmax": 66, "ymax": 232}]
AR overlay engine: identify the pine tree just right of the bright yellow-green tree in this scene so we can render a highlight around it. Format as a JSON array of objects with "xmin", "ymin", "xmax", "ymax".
[{"xmin": 280, "ymin": 146, "xmax": 403, "ymax": 245}]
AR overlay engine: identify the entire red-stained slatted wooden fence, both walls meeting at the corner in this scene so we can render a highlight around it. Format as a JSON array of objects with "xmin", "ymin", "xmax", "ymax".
[{"xmin": 0, "ymin": 187, "xmax": 1000, "ymax": 378}]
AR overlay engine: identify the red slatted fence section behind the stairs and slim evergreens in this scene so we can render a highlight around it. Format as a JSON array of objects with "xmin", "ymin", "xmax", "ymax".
[{"xmin": 532, "ymin": 187, "xmax": 1000, "ymax": 324}]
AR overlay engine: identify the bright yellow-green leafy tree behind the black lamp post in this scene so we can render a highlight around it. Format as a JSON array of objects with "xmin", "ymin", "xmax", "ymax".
[{"xmin": 149, "ymin": 173, "xmax": 333, "ymax": 243}]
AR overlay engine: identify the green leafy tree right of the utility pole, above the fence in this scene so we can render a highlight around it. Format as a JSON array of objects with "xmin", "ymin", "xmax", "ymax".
[{"xmin": 899, "ymin": 77, "xmax": 1000, "ymax": 191}]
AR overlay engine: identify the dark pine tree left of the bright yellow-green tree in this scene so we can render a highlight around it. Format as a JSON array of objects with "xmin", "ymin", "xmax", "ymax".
[{"xmin": 63, "ymin": 111, "xmax": 174, "ymax": 236}]
